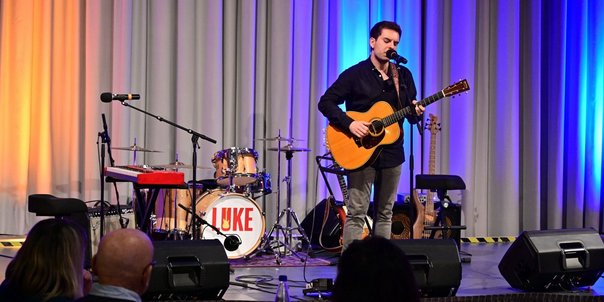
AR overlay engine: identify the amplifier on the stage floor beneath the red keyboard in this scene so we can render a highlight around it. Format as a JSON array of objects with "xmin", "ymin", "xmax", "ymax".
[{"xmin": 88, "ymin": 206, "xmax": 136, "ymax": 256}]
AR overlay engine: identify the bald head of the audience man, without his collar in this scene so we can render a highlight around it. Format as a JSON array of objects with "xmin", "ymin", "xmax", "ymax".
[{"xmin": 92, "ymin": 229, "xmax": 153, "ymax": 295}]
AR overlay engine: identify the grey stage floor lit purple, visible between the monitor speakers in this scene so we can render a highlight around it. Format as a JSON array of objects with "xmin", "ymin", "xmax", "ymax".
[{"xmin": 0, "ymin": 236, "xmax": 604, "ymax": 301}]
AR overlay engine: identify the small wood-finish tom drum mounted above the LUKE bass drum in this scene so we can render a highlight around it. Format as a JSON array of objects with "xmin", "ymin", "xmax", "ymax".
[{"xmin": 212, "ymin": 147, "xmax": 258, "ymax": 186}]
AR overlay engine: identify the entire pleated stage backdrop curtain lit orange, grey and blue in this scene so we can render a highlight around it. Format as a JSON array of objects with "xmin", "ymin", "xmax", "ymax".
[{"xmin": 0, "ymin": 0, "xmax": 604, "ymax": 236}]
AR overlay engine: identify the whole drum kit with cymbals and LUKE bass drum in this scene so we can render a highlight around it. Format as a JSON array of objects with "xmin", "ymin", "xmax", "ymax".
[{"xmin": 112, "ymin": 133, "xmax": 311, "ymax": 263}]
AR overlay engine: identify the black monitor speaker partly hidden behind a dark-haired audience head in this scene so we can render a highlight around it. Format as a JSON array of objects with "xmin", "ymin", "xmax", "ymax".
[{"xmin": 392, "ymin": 239, "xmax": 461, "ymax": 297}]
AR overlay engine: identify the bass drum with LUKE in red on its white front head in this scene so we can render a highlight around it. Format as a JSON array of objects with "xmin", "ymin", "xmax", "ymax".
[{"xmin": 195, "ymin": 190, "xmax": 265, "ymax": 259}]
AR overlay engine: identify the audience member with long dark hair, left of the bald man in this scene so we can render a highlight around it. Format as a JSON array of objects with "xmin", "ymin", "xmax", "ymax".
[{"xmin": 0, "ymin": 218, "xmax": 91, "ymax": 302}]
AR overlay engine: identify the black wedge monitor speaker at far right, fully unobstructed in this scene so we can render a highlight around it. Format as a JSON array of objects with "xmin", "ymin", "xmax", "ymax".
[{"xmin": 499, "ymin": 229, "xmax": 604, "ymax": 291}]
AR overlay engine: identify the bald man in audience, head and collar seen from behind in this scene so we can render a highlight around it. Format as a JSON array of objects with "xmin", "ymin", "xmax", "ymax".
[{"xmin": 77, "ymin": 229, "xmax": 153, "ymax": 301}]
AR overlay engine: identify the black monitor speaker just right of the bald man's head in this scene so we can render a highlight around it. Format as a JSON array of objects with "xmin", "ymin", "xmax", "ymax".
[{"xmin": 144, "ymin": 239, "xmax": 230, "ymax": 300}]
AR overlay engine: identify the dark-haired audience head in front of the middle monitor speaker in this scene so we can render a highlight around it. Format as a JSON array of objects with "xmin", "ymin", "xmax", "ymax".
[{"xmin": 332, "ymin": 237, "xmax": 419, "ymax": 302}]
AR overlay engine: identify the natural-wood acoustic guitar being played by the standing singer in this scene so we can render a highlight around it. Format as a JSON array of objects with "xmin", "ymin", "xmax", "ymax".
[{"xmin": 326, "ymin": 80, "xmax": 470, "ymax": 170}]
